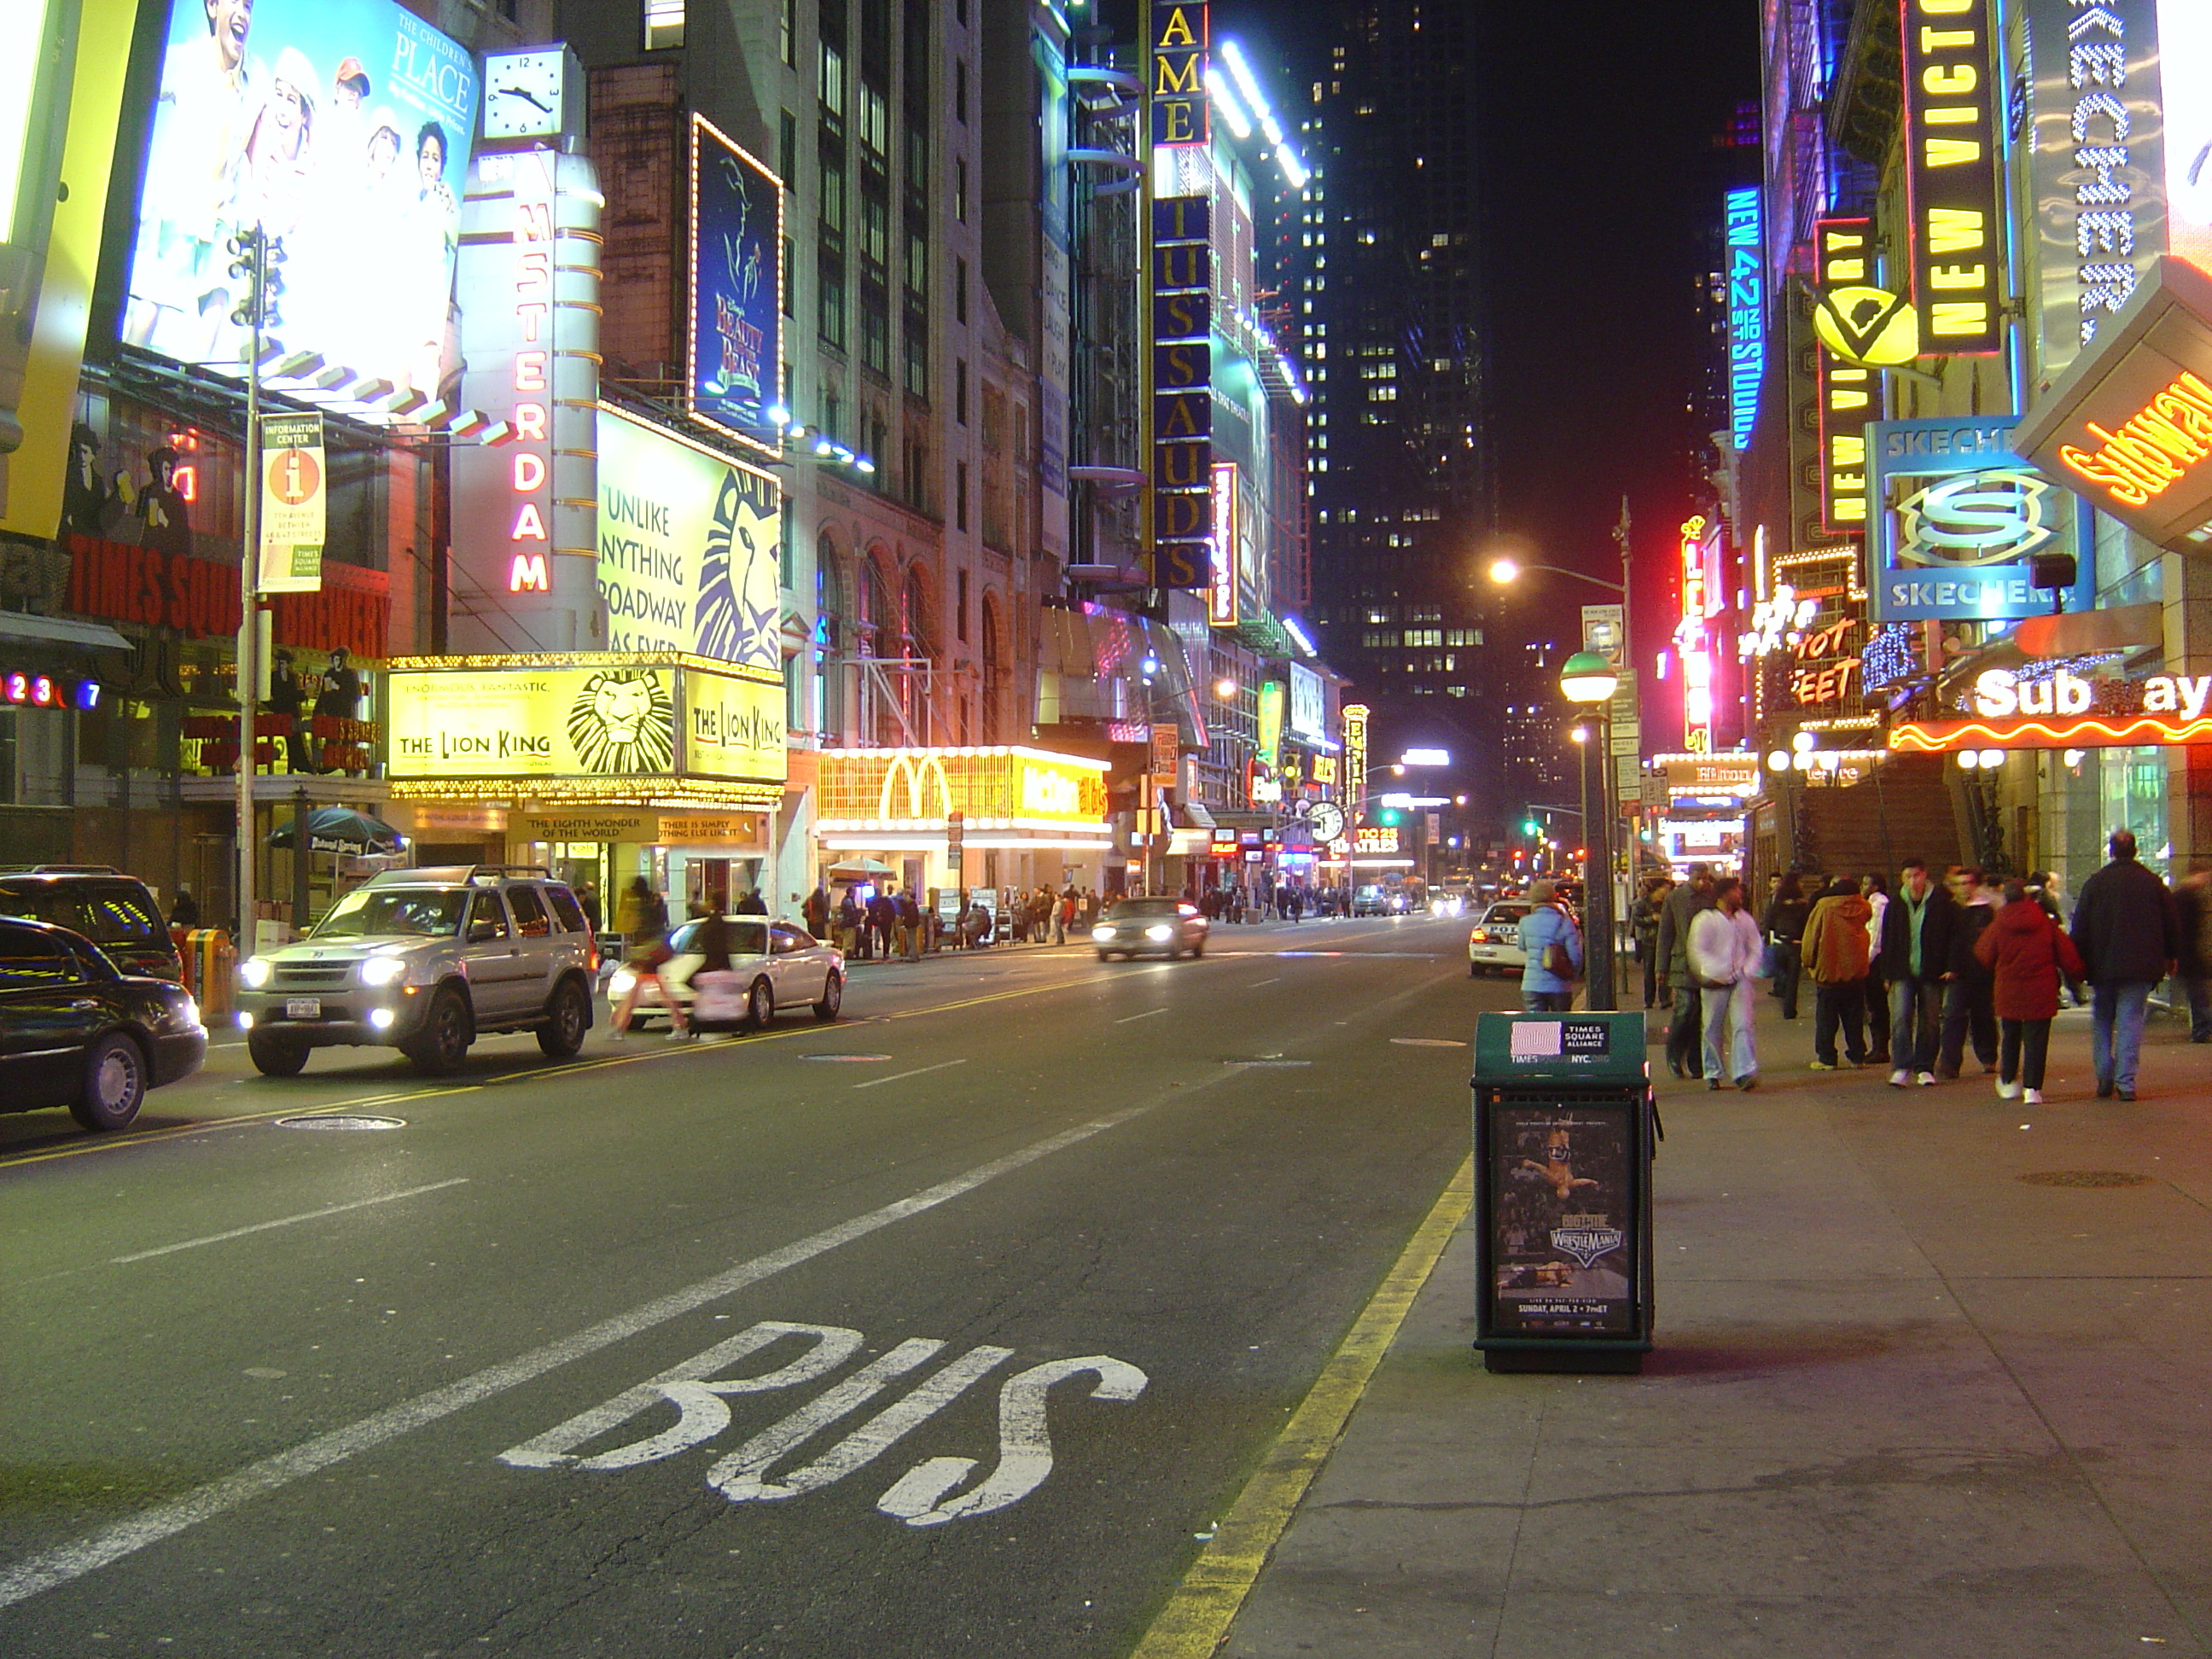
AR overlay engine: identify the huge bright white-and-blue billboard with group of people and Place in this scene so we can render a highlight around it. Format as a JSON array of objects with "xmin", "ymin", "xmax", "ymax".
[{"xmin": 124, "ymin": 0, "xmax": 478, "ymax": 418}]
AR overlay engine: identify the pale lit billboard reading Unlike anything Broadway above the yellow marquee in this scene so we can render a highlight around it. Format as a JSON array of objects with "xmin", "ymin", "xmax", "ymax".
[{"xmin": 597, "ymin": 405, "xmax": 783, "ymax": 672}]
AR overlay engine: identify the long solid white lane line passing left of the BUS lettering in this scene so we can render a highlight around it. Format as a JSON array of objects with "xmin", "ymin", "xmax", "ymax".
[{"xmin": 0, "ymin": 1106, "xmax": 1148, "ymax": 1608}]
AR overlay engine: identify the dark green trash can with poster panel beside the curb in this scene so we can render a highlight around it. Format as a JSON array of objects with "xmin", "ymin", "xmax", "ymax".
[{"xmin": 1473, "ymin": 1011, "xmax": 1659, "ymax": 1371}]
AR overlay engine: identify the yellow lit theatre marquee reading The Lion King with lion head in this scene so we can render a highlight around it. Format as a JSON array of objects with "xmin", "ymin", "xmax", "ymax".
[{"xmin": 385, "ymin": 653, "xmax": 785, "ymax": 800}]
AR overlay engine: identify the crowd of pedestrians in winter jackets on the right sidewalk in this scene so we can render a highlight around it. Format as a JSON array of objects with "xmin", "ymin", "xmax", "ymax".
[{"xmin": 1619, "ymin": 830, "xmax": 2212, "ymax": 1103}]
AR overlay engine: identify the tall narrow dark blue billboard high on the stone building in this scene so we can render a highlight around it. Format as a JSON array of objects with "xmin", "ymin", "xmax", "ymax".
[{"xmin": 688, "ymin": 115, "xmax": 783, "ymax": 453}]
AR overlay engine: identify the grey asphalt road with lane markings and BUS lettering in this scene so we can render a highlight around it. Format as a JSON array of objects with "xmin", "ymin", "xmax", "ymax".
[{"xmin": 0, "ymin": 920, "xmax": 1513, "ymax": 1659}]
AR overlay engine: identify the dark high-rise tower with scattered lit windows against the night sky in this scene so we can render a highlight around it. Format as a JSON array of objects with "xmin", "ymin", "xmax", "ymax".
[{"xmin": 1283, "ymin": 0, "xmax": 1495, "ymax": 800}]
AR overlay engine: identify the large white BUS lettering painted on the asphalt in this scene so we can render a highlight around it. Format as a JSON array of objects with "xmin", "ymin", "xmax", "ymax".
[{"xmin": 500, "ymin": 1320, "xmax": 1148, "ymax": 1526}]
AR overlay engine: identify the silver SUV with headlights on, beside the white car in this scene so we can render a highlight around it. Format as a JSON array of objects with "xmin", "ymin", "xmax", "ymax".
[{"xmin": 239, "ymin": 864, "xmax": 597, "ymax": 1077}]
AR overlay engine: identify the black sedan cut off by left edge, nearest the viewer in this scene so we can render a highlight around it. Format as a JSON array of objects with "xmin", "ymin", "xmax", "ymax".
[{"xmin": 0, "ymin": 916, "xmax": 208, "ymax": 1131}]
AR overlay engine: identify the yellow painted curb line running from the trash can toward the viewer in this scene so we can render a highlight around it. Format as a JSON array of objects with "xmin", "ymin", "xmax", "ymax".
[{"xmin": 1131, "ymin": 1157, "xmax": 1476, "ymax": 1659}]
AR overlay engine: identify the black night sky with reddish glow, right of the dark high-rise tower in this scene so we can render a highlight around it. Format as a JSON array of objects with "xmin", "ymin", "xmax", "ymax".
[{"xmin": 1212, "ymin": 0, "xmax": 1759, "ymax": 677}]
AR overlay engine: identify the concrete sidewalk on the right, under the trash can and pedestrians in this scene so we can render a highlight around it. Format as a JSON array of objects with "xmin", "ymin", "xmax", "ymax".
[{"xmin": 1221, "ymin": 998, "xmax": 2212, "ymax": 1659}]
